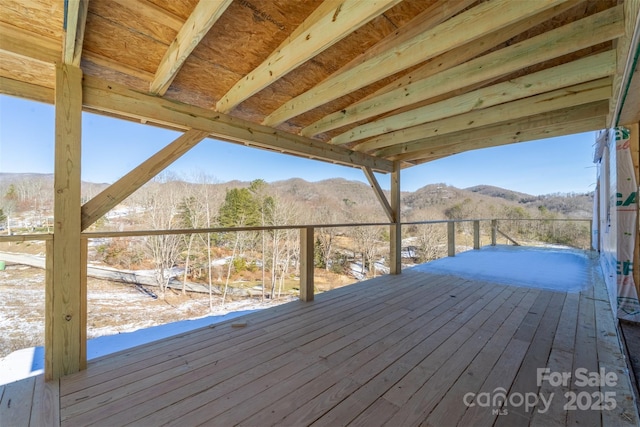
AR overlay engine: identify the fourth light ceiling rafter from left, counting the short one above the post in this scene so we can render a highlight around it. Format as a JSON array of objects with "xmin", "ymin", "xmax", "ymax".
[{"xmin": 263, "ymin": 0, "xmax": 566, "ymax": 126}]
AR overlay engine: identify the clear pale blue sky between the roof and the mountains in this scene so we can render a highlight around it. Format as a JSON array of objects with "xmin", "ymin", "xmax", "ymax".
[{"xmin": 0, "ymin": 95, "xmax": 596, "ymax": 195}]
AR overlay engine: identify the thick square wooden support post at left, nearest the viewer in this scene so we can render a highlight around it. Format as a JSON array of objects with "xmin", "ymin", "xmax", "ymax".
[{"xmin": 45, "ymin": 64, "xmax": 86, "ymax": 379}]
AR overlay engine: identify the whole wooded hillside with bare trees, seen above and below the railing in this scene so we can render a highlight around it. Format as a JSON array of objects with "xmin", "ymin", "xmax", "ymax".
[{"xmin": 0, "ymin": 173, "xmax": 592, "ymax": 306}]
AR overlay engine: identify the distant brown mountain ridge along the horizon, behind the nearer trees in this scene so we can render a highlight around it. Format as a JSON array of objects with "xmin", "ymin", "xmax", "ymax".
[{"xmin": 0, "ymin": 173, "xmax": 593, "ymax": 223}]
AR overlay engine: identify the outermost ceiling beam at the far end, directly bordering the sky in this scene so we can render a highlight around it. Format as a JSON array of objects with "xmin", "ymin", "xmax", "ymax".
[{"xmin": 390, "ymin": 100, "xmax": 608, "ymax": 161}]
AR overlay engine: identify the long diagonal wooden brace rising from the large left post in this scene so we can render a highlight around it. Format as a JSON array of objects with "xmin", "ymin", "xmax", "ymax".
[{"xmin": 81, "ymin": 129, "xmax": 209, "ymax": 230}]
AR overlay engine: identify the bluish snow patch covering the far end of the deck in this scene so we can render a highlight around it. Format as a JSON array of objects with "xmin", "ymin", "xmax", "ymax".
[{"xmin": 413, "ymin": 246, "xmax": 590, "ymax": 292}]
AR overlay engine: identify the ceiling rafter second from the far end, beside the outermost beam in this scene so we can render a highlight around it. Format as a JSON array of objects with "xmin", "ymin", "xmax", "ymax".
[{"xmin": 362, "ymin": 77, "xmax": 611, "ymax": 157}]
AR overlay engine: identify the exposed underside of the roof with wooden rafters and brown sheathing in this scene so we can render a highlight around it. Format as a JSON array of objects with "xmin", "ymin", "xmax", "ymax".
[{"xmin": 0, "ymin": 0, "xmax": 640, "ymax": 174}]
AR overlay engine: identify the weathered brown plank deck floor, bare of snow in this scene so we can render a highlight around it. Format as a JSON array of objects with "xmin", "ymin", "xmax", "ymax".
[{"xmin": 0, "ymin": 256, "xmax": 638, "ymax": 427}]
